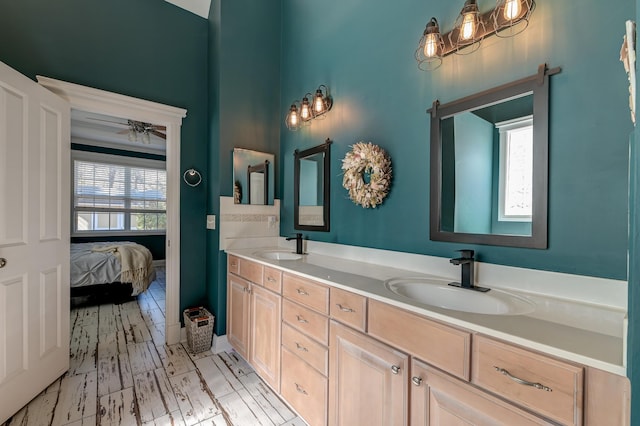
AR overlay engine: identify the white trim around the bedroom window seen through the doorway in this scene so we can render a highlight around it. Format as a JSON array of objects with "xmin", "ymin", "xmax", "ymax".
[{"xmin": 69, "ymin": 150, "xmax": 167, "ymax": 237}]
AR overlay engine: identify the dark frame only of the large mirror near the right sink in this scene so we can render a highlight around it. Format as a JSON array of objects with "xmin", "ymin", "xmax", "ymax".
[{"xmin": 427, "ymin": 64, "xmax": 560, "ymax": 249}]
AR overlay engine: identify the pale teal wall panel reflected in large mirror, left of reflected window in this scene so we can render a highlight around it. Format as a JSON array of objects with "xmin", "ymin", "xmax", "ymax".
[{"xmin": 453, "ymin": 113, "xmax": 493, "ymax": 234}]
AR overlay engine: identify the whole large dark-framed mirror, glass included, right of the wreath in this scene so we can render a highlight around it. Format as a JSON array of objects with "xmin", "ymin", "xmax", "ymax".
[{"xmin": 428, "ymin": 64, "xmax": 560, "ymax": 248}]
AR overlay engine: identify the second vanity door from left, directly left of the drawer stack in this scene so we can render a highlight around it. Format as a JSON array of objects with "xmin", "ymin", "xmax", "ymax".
[{"xmin": 249, "ymin": 286, "xmax": 282, "ymax": 391}]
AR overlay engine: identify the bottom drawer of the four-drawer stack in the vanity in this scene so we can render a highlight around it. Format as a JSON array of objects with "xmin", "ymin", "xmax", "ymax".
[{"xmin": 280, "ymin": 348, "xmax": 329, "ymax": 426}]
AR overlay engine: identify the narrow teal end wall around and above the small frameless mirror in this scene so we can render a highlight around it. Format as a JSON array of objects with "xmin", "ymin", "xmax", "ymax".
[{"xmin": 207, "ymin": 0, "xmax": 281, "ymax": 335}]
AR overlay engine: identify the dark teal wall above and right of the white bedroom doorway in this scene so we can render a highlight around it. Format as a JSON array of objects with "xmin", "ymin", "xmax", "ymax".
[{"xmin": 0, "ymin": 0, "xmax": 208, "ymax": 307}]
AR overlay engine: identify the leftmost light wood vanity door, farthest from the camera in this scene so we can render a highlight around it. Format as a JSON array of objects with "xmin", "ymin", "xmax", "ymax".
[{"xmin": 227, "ymin": 274, "xmax": 251, "ymax": 359}]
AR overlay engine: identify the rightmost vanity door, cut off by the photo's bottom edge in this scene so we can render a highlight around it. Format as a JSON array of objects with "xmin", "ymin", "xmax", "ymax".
[{"xmin": 411, "ymin": 359, "xmax": 551, "ymax": 426}]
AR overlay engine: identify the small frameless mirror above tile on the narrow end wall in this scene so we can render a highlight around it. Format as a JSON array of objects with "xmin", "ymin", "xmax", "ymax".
[{"xmin": 233, "ymin": 148, "xmax": 275, "ymax": 205}]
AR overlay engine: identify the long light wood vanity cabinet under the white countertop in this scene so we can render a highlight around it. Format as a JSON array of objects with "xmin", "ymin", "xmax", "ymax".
[{"xmin": 227, "ymin": 255, "xmax": 630, "ymax": 426}]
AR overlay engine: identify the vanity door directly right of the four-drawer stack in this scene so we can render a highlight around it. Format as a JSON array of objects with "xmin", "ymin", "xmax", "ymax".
[{"xmin": 329, "ymin": 321, "xmax": 409, "ymax": 426}]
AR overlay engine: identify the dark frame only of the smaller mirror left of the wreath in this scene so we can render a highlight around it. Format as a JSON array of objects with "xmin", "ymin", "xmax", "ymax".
[{"xmin": 293, "ymin": 139, "xmax": 332, "ymax": 232}]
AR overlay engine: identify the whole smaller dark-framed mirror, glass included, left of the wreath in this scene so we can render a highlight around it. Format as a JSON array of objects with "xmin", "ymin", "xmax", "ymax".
[{"xmin": 293, "ymin": 139, "xmax": 331, "ymax": 232}]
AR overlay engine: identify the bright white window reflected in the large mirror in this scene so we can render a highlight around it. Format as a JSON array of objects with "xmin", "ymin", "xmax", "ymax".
[{"xmin": 496, "ymin": 116, "xmax": 533, "ymax": 222}]
